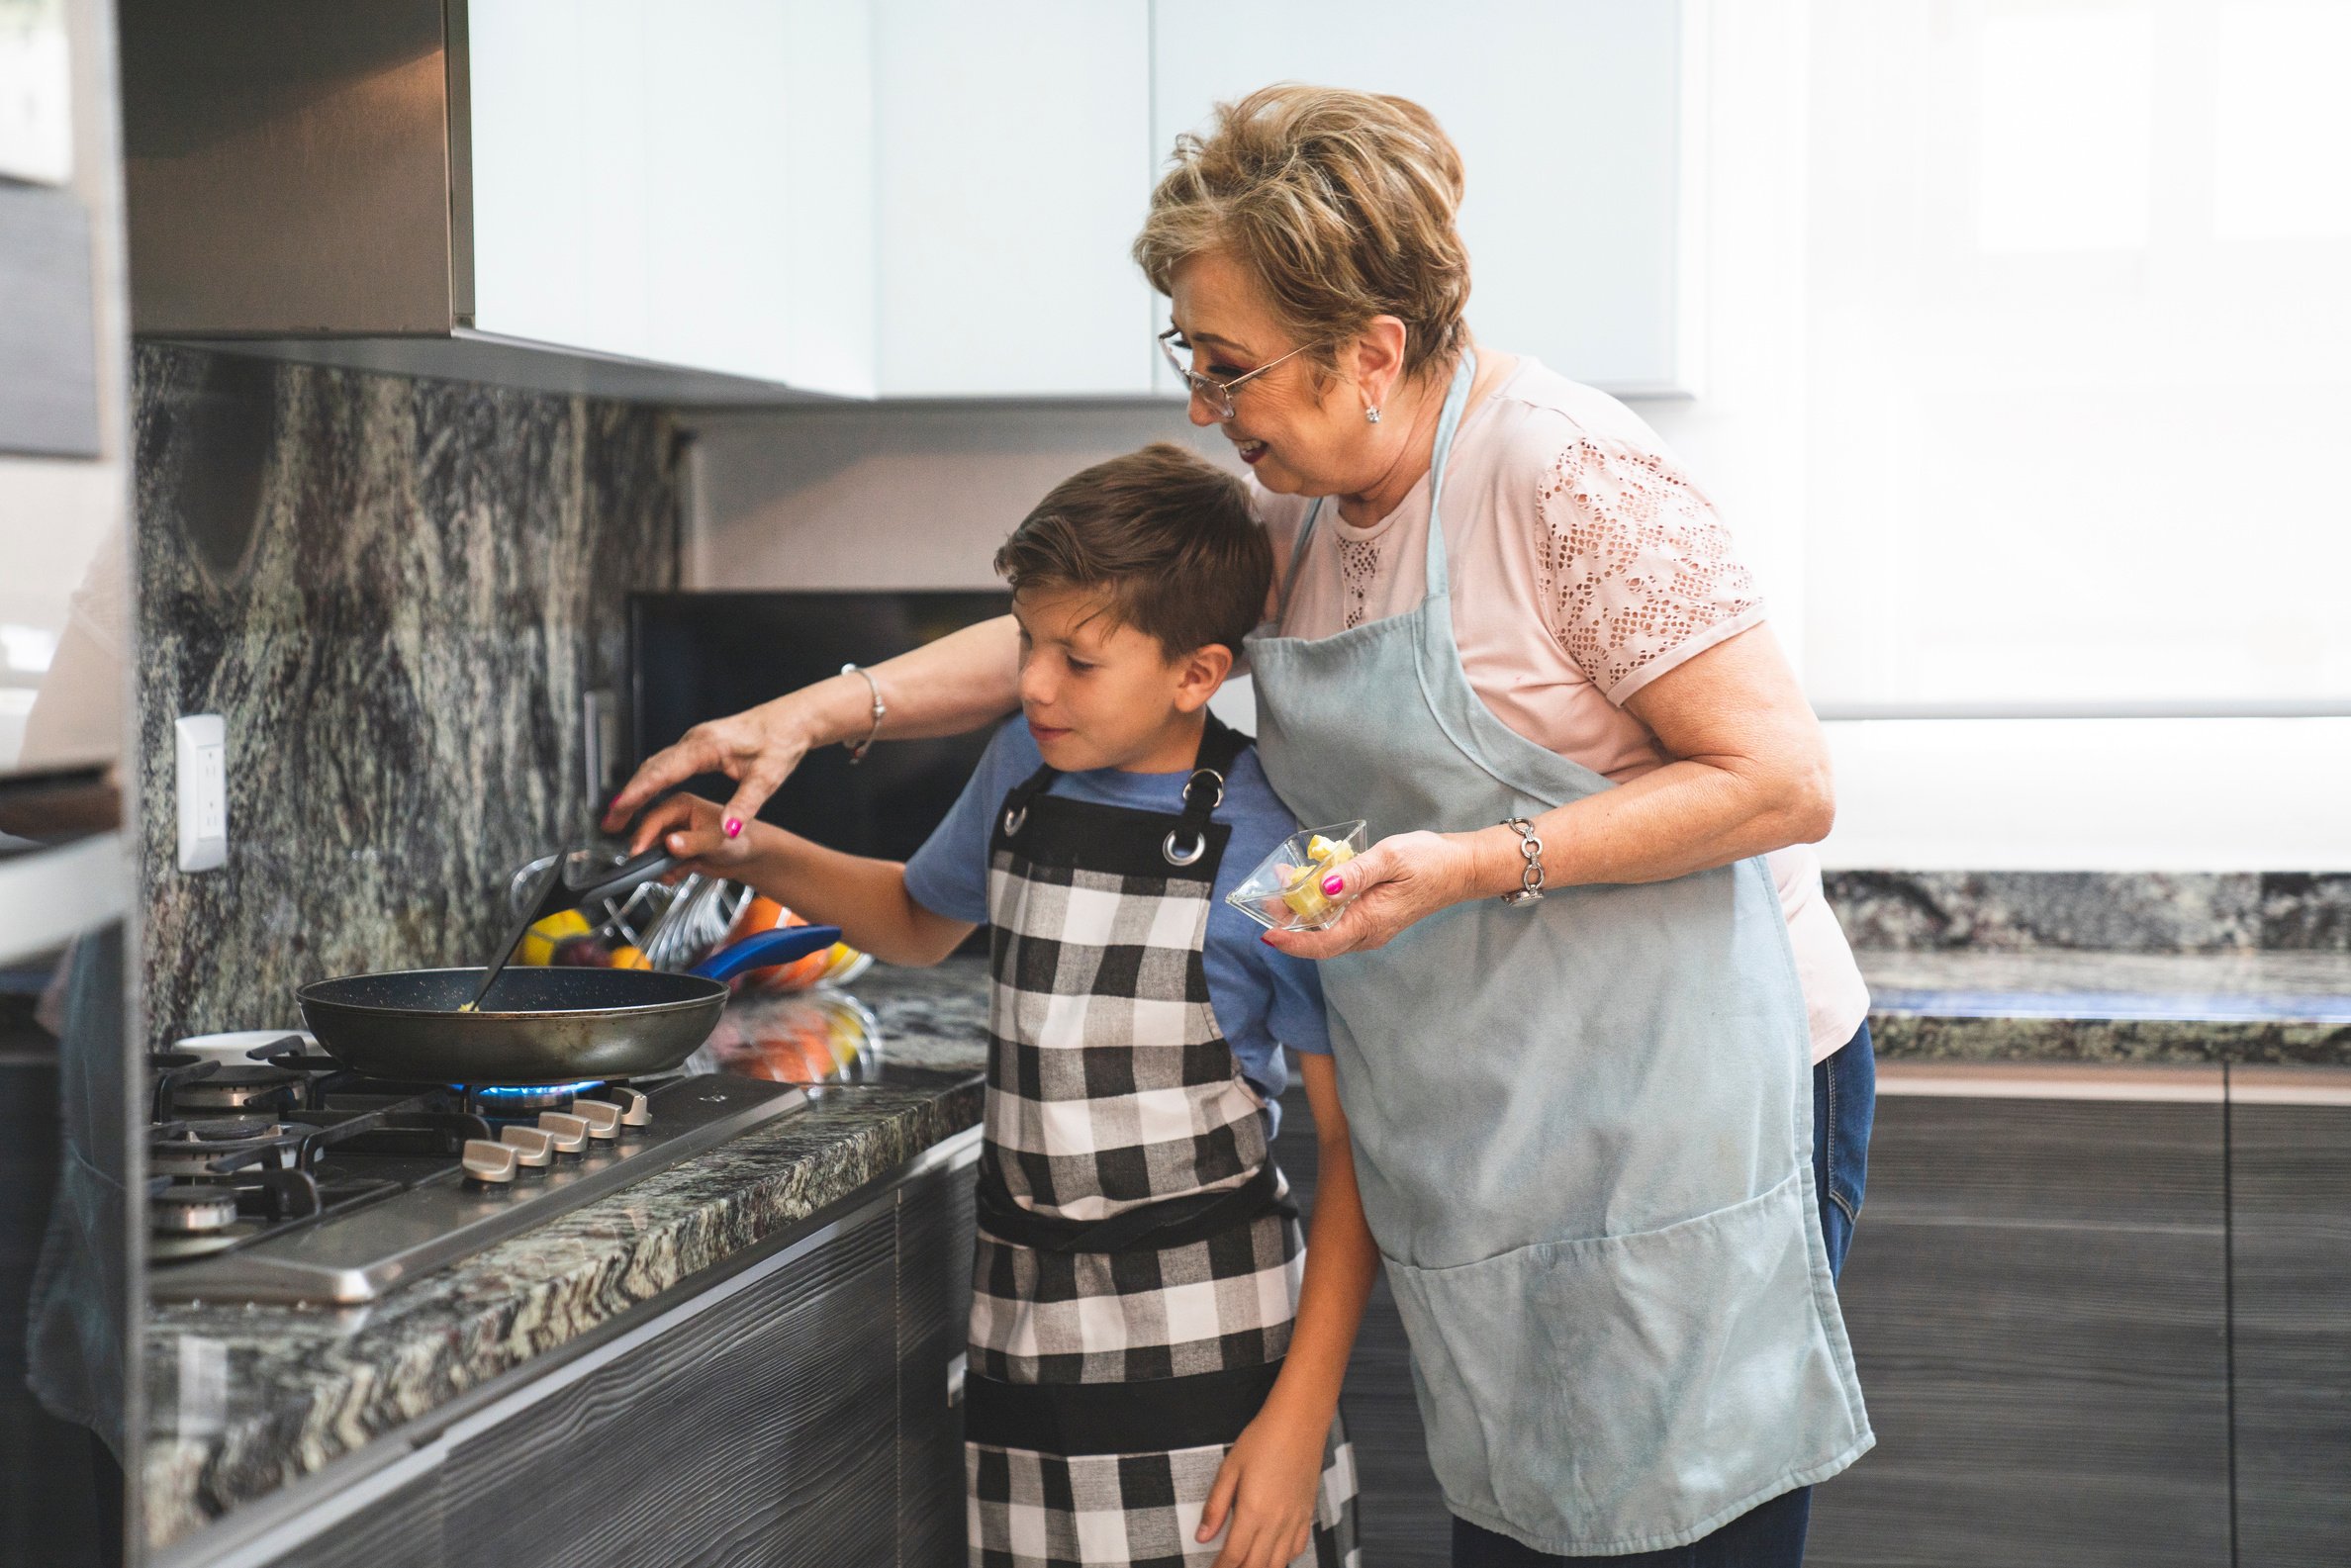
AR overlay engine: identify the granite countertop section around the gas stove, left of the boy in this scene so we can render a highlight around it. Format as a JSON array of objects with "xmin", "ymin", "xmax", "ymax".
[{"xmin": 139, "ymin": 960, "xmax": 987, "ymax": 1547}]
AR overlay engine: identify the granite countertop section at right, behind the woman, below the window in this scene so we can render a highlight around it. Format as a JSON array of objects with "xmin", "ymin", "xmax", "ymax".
[{"xmin": 1855, "ymin": 948, "xmax": 2351, "ymax": 1064}]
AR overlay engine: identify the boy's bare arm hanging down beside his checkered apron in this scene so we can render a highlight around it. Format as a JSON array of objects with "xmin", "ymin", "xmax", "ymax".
[{"xmin": 1199, "ymin": 1051, "xmax": 1380, "ymax": 1568}]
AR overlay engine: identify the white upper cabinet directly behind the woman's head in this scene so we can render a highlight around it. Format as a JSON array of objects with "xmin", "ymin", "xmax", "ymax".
[{"xmin": 1152, "ymin": 0, "xmax": 1697, "ymax": 395}]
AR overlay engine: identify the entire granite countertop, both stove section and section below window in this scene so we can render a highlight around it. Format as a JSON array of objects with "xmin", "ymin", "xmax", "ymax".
[{"xmin": 141, "ymin": 950, "xmax": 2351, "ymax": 1547}]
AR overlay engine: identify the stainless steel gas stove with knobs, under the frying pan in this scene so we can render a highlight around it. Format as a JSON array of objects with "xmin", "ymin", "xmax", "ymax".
[{"xmin": 148, "ymin": 1035, "xmax": 806, "ymax": 1305}]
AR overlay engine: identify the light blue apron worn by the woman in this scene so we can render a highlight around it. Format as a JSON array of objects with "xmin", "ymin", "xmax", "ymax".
[{"xmin": 1249, "ymin": 355, "xmax": 1876, "ymax": 1556}]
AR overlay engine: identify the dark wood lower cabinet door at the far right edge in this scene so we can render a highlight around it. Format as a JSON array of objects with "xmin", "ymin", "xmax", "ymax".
[{"xmin": 2228, "ymin": 1067, "xmax": 2351, "ymax": 1568}]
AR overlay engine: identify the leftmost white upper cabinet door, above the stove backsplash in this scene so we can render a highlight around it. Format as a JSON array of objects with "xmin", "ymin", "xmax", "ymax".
[{"xmin": 465, "ymin": 0, "xmax": 872, "ymax": 395}]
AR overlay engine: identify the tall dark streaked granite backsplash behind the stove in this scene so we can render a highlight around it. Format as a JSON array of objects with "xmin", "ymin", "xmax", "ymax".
[{"xmin": 132, "ymin": 345, "xmax": 680, "ymax": 1042}]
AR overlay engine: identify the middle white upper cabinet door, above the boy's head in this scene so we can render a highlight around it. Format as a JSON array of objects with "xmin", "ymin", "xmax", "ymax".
[{"xmin": 874, "ymin": 0, "xmax": 1164, "ymax": 398}]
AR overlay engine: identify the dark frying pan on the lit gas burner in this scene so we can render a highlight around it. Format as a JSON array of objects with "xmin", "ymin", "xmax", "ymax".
[{"xmin": 296, "ymin": 856, "xmax": 842, "ymax": 1086}]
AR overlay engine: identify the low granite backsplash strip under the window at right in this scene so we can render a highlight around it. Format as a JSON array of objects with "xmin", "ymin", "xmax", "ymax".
[{"xmin": 1827, "ymin": 870, "xmax": 2351, "ymax": 952}]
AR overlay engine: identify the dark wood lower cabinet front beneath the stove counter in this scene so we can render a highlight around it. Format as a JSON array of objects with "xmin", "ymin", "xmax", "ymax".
[{"xmin": 229, "ymin": 1138, "xmax": 978, "ymax": 1568}]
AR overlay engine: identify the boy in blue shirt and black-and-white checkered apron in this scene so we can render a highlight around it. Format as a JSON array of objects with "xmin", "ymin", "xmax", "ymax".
[{"xmin": 637, "ymin": 442, "xmax": 1375, "ymax": 1568}]
